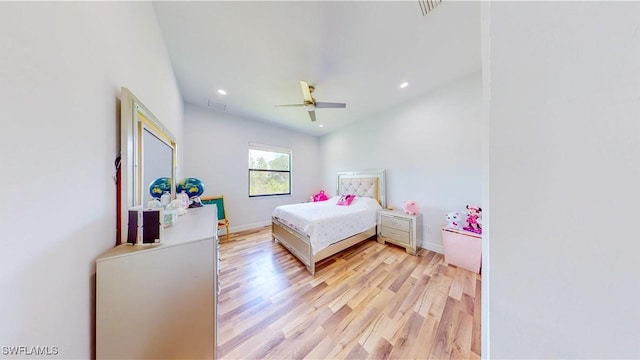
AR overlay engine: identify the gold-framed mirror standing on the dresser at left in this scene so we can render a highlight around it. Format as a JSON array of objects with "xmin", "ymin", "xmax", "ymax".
[{"xmin": 119, "ymin": 87, "xmax": 177, "ymax": 243}]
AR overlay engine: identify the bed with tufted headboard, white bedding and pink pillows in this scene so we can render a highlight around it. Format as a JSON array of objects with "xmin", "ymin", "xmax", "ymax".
[{"xmin": 271, "ymin": 170, "xmax": 386, "ymax": 275}]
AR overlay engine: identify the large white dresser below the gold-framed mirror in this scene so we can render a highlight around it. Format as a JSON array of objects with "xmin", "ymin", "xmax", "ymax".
[{"xmin": 96, "ymin": 205, "xmax": 218, "ymax": 359}]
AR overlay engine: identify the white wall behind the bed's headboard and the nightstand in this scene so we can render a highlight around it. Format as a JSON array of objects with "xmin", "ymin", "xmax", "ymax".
[{"xmin": 321, "ymin": 72, "xmax": 482, "ymax": 252}]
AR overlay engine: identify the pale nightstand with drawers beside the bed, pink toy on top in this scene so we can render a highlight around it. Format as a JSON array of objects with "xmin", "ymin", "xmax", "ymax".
[{"xmin": 378, "ymin": 210, "xmax": 422, "ymax": 255}]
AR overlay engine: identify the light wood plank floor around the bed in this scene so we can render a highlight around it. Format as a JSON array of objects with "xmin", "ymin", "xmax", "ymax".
[{"xmin": 217, "ymin": 227, "xmax": 481, "ymax": 359}]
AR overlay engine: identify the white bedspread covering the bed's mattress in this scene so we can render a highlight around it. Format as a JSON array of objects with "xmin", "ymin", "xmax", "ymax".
[{"xmin": 273, "ymin": 196, "xmax": 382, "ymax": 255}]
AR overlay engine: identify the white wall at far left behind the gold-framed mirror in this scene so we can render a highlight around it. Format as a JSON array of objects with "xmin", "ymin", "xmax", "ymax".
[{"xmin": 0, "ymin": 2, "xmax": 182, "ymax": 359}]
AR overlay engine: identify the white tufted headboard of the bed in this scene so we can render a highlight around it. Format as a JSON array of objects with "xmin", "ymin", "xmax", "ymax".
[{"xmin": 336, "ymin": 170, "xmax": 387, "ymax": 208}]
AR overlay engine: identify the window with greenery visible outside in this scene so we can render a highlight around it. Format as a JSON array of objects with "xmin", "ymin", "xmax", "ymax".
[{"xmin": 249, "ymin": 143, "xmax": 291, "ymax": 197}]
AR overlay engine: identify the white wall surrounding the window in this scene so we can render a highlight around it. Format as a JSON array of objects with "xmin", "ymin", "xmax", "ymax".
[{"xmin": 183, "ymin": 104, "xmax": 321, "ymax": 232}]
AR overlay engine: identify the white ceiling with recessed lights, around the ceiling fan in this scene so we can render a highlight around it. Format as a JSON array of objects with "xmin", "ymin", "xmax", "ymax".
[{"xmin": 153, "ymin": 0, "xmax": 481, "ymax": 136}]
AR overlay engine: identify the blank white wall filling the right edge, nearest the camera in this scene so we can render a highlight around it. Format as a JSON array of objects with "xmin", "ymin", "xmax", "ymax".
[{"xmin": 483, "ymin": 2, "xmax": 640, "ymax": 359}]
